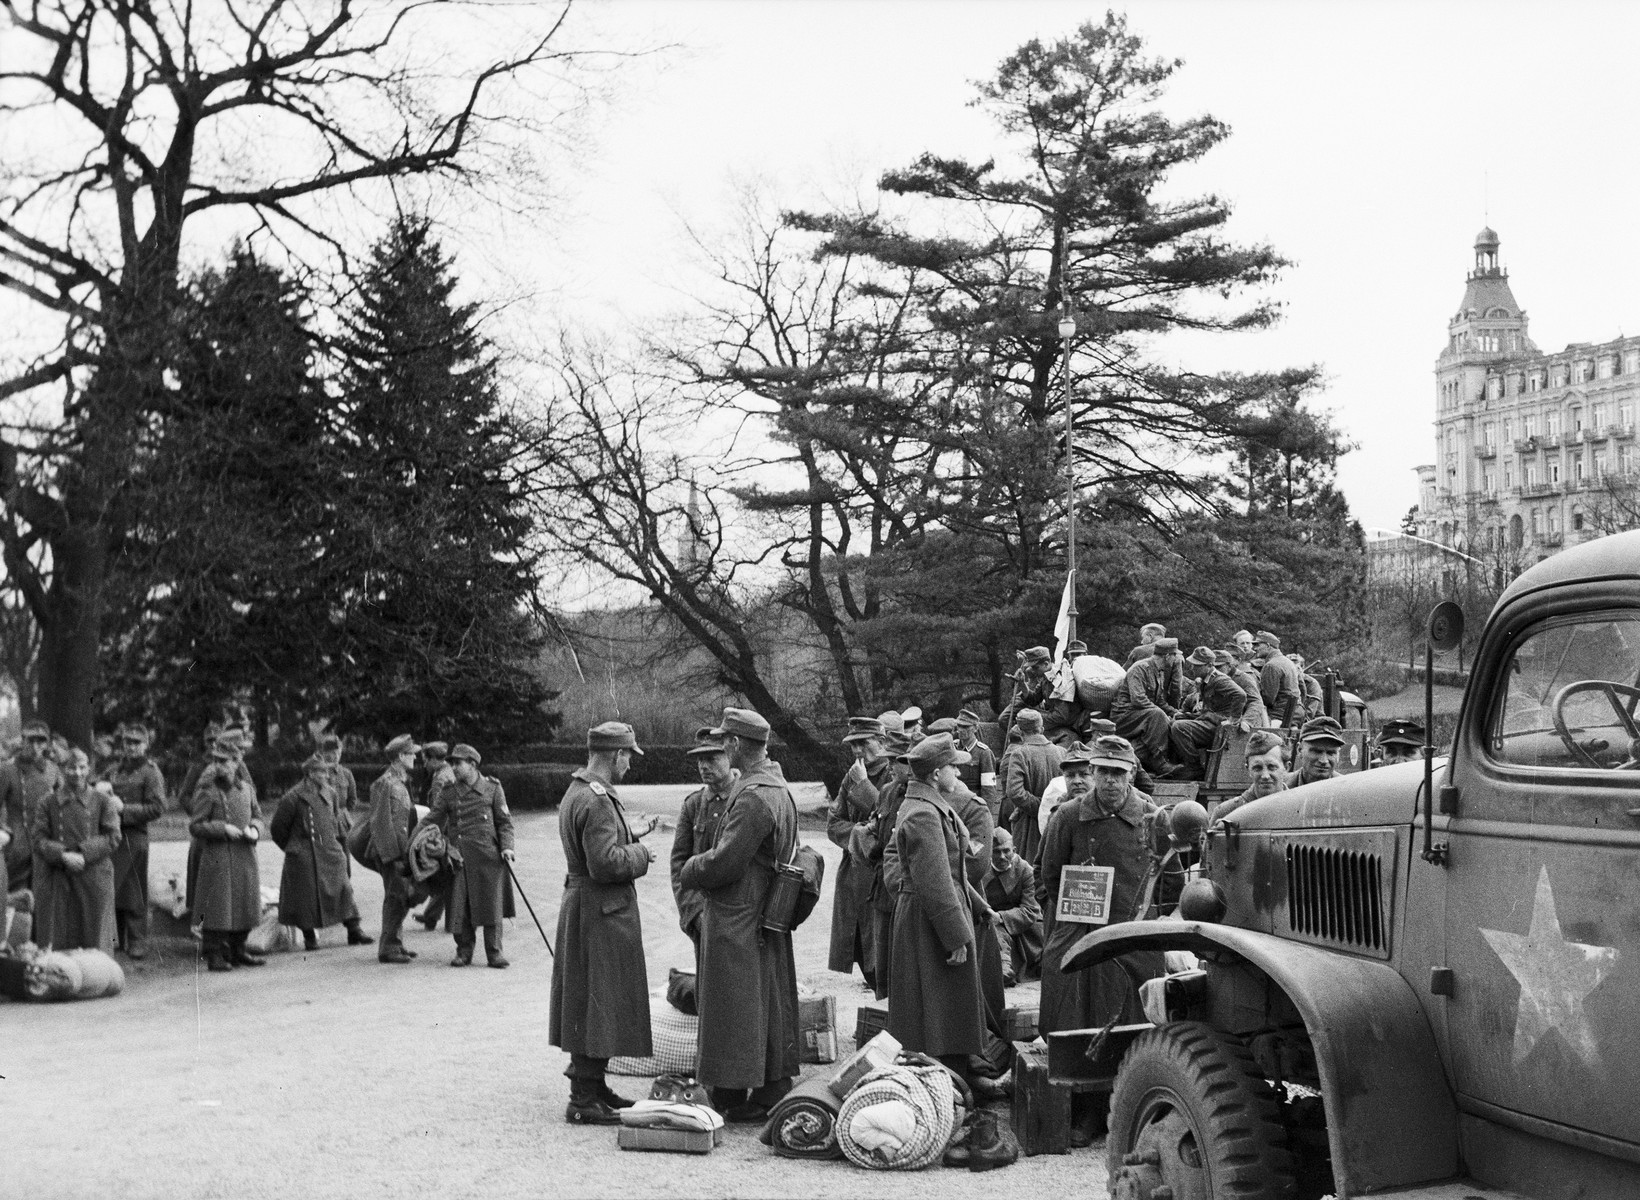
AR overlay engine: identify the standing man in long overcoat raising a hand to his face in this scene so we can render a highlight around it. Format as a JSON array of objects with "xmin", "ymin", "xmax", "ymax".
[{"xmin": 825, "ymin": 716, "xmax": 894, "ymax": 987}]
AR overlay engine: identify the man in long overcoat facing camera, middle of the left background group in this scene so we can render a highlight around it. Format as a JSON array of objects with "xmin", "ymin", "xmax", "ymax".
[{"xmin": 189, "ymin": 734, "xmax": 267, "ymax": 970}]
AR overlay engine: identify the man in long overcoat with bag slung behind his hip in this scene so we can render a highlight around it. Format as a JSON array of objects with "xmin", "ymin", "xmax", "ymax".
[{"xmin": 681, "ymin": 708, "xmax": 799, "ymax": 1121}]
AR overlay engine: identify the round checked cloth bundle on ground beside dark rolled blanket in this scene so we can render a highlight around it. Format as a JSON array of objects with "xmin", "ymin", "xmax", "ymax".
[{"xmin": 836, "ymin": 1066, "xmax": 958, "ymax": 1170}]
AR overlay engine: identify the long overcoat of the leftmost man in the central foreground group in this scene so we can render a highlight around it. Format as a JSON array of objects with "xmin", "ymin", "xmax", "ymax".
[{"xmin": 548, "ymin": 767, "xmax": 654, "ymax": 1059}]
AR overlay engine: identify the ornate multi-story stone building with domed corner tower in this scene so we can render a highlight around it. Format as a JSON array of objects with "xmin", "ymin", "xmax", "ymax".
[{"xmin": 1374, "ymin": 230, "xmax": 1640, "ymax": 574}]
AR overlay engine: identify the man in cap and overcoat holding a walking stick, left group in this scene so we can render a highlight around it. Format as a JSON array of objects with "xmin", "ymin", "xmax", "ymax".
[{"xmin": 428, "ymin": 744, "xmax": 515, "ymax": 967}]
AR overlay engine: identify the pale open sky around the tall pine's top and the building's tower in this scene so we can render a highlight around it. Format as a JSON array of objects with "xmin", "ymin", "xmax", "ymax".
[{"xmin": 513, "ymin": 0, "xmax": 1640, "ymax": 526}]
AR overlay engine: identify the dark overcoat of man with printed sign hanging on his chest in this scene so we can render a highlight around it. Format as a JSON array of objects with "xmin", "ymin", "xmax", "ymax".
[{"xmin": 1036, "ymin": 789, "xmax": 1164, "ymax": 1038}]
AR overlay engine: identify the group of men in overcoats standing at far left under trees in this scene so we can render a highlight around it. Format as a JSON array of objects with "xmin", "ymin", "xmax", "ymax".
[{"xmin": 0, "ymin": 721, "xmax": 513, "ymax": 972}]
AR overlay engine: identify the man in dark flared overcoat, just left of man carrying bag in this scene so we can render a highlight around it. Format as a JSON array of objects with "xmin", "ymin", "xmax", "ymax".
[{"xmin": 269, "ymin": 754, "xmax": 376, "ymax": 949}]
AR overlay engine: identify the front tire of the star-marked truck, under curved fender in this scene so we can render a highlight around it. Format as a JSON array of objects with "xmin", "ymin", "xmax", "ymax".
[{"xmin": 1105, "ymin": 1021, "xmax": 1297, "ymax": 1200}]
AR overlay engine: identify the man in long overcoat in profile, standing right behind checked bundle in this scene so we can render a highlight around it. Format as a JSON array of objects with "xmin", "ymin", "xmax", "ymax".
[{"xmin": 882, "ymin": 734, "xmax": 986, "ymax": 1077}]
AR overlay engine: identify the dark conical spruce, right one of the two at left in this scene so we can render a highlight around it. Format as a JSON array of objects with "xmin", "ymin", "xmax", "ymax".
[{"xmin": 330, "ymin": 218, "xmax": 556, "ymax": 744}]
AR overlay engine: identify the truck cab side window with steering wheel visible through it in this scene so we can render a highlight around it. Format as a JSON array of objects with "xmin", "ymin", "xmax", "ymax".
[{"xmin": 1491, "ymin": 613, "xmax": 1640, "ymax": 770}]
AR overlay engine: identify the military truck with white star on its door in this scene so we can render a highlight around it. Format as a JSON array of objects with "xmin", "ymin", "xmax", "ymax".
[{"xmin": 1064, "ymin": 533, "xmax": 1640, "ymax": 1200}]
